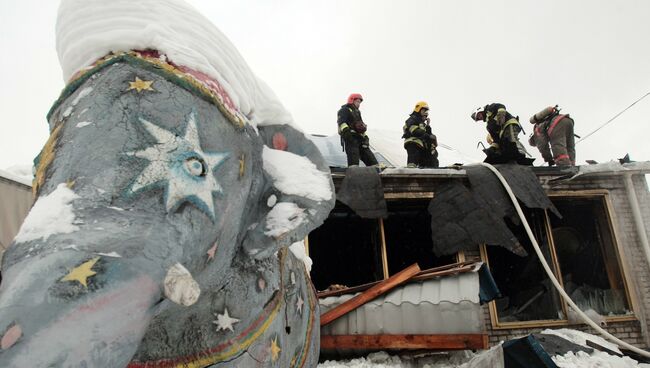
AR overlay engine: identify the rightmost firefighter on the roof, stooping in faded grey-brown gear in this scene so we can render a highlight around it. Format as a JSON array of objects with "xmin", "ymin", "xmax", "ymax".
[{"xmin": 529, "ymin": 105, "xmax": 576, "ymax": 166}]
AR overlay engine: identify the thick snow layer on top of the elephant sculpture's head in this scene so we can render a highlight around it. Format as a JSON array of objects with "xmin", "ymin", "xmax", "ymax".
[{"xmin": 56, "ymin": 0, "xmax": 293, "ymax": 129}]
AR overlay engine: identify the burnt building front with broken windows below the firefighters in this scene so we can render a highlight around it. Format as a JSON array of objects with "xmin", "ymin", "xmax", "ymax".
[{"xmin": 307, "ymin": 162, "xmax": 650, "ymax": 348}]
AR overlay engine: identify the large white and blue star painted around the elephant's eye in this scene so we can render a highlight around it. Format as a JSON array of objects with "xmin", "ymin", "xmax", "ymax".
[{"xmin": 127, "ymin": 112, "xmax": 229, "ymax": 221}]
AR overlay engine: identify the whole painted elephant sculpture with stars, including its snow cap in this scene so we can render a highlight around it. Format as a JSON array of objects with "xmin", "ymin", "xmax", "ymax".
[{"xmin": 0, "ymin": 0, "xmax": 334, "ymax": 368}]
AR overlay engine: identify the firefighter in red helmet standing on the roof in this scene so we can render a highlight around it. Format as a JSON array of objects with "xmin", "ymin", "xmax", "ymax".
[{"xmin": 337, "ymin": 93, "xmax": 378, "ymax": 167}]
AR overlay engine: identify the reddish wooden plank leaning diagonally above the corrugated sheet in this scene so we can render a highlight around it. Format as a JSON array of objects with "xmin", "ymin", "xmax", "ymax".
[{"xmin": 320, "ymin": 263, "xmax": 420, "ymax": 326}]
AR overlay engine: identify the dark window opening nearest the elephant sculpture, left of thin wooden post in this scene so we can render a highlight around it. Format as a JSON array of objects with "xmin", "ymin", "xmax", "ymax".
[{"xmin": 309, "ymin": 204, "xmax": 384, "ymax": 290}]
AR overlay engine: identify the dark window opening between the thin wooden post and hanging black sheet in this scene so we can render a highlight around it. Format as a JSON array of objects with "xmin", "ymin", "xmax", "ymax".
[{"xmin": 383, "ymin": 200, "xmax": 456, "ymax": 275}]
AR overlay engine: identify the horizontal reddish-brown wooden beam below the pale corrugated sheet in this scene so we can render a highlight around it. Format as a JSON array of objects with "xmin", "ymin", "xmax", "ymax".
[{"xmin": 320, "ymin": 333, "xmax": 488, "ymax": 350}]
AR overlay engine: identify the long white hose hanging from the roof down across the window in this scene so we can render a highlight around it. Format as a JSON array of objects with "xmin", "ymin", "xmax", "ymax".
[{"xmin": 479, "ymin": 162, "xmax": 650, "ymax": 358}]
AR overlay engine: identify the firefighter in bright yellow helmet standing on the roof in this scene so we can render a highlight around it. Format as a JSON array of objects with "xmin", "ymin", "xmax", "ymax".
[{"xmin": 402, "ymin": 101, "xmax": 439, "ymax": 168}]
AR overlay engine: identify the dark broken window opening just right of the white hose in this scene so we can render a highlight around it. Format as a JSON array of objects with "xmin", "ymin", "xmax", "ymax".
[{"xmin": 551, "ymin": 195, "xmax": 632, "ymax": 316}]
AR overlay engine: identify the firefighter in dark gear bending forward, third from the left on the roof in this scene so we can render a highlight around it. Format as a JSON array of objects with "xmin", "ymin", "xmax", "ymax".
[{"xmin": 471, "ymin": 103, "xmax": 533, "ymax": 165}]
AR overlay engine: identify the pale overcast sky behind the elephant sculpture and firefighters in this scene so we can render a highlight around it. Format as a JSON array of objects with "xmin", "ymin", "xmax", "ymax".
[{"xmin": 0, "ymin": 0, "xmax": 650, "ymax": 169}]
